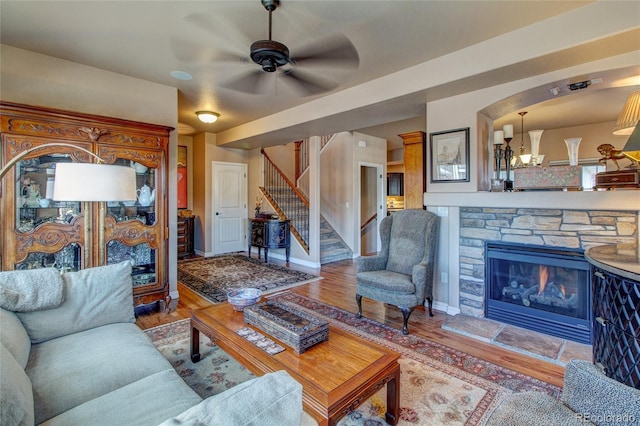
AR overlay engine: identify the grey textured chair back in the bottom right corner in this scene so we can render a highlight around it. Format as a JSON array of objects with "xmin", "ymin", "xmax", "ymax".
[{"xmin": 562, "ymin": 359, "xmax": 640, "ymax": 425}]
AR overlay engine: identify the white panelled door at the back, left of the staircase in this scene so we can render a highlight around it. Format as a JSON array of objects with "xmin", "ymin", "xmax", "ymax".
[{"xmin": 211, "ymin": 161, "xmax": 248, "ymax": 254}]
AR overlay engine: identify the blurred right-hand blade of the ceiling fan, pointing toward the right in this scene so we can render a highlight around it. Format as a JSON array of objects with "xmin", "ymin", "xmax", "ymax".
[{"xmin": 292, "ymin": 34, "xmax": 360, "ymax": 69}]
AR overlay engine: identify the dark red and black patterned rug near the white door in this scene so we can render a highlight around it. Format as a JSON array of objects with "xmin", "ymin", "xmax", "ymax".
[{"xmin": 178, "ymin": 254, "xmax": 322, "ymax": 303}]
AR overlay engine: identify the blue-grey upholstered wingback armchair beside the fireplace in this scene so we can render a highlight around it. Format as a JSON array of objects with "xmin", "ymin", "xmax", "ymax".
[{"xmin": 356, "ymin": 209, "xmax": 440, "ymax": 334}]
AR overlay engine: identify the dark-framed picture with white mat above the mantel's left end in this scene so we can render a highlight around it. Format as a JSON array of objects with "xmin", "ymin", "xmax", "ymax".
[{"xmin": 429, "ymin": 127, "xmax": 469, "ymax": 183}]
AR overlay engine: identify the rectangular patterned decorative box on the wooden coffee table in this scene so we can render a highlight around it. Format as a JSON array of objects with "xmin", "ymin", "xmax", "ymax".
[{"xmin": 244, "ymin": 301, "xmax": 329, "ymax": 355}]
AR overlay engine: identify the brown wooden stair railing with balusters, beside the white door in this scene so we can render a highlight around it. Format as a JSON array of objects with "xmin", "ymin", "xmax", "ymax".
[{"xmin": 260, "ymin": 149, "xmax": 309, "ymax": 254}]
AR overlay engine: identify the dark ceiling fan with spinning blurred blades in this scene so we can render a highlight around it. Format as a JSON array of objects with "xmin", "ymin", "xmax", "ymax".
[{"xmin": 225, "ymin": 0, "xmax": 360, "ymax": 96}]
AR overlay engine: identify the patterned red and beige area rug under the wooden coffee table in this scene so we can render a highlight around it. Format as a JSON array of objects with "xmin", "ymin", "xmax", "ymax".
[{"xmin": 147, "ymin": 292, "xmax": 561, "ymax": 426}]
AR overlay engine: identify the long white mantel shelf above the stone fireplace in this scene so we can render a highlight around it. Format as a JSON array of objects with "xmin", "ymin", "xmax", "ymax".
[{"xmin": 424, "ymin": 190, "xmax": 640, "ymax": 211}]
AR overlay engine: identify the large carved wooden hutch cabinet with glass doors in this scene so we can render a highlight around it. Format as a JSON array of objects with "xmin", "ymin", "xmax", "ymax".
[{"xmin": 0, "ymin": 102, "xmax": 173, "ymax": 309}]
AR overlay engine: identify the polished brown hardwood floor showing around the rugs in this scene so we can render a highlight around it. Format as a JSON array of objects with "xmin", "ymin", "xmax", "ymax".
[{"xmin": 137, "ymin": 260, "xmax": 564, "ymax": 386}]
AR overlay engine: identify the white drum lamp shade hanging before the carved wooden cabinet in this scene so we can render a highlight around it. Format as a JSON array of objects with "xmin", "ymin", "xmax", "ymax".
[{"xmin": 53, "ymin": 163, "xmax": 136, "ymax": 201}]
